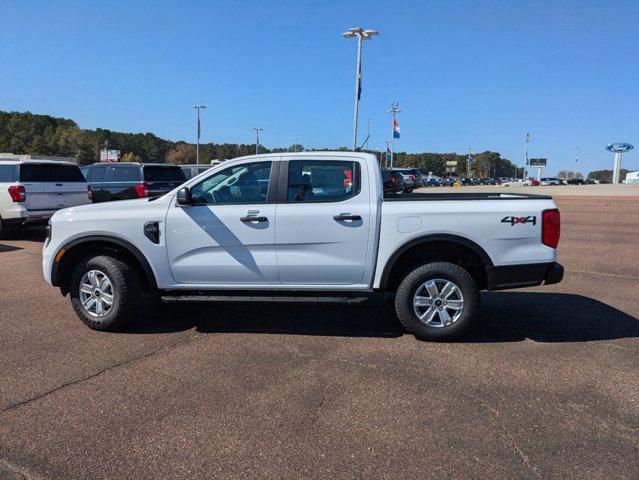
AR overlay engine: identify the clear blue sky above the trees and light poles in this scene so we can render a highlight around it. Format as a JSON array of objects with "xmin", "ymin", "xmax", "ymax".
[{"xmin": 0, "ymin": 0, "xmax": 639, "ymax": 173}]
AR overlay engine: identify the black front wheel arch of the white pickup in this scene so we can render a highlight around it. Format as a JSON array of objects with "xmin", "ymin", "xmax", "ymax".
[{"xmin": 51, "ymin": 235, "xmax": 158, "ymax": 295}]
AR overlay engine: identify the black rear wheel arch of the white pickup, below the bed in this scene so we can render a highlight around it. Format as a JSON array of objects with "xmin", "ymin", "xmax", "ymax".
[{"xmin": 379, "ymin": 233, "xmax": 493, "ymax": 290}]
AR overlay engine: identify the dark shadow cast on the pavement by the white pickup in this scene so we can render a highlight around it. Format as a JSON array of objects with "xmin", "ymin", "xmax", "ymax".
[{"xmin": 122, "ymin": 292, "xmax": 639, "ymax": 343}]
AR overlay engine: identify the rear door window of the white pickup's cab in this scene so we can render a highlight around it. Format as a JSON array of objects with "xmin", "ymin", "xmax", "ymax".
[{"xmin": 288, "ymin": 160, "xmax": 359, "ymax": 203}]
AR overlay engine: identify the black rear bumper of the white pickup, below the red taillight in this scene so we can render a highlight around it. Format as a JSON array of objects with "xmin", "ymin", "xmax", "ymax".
[{"xmin": 486, "ymin": 262, "xmax": 564, "ymax": 290}]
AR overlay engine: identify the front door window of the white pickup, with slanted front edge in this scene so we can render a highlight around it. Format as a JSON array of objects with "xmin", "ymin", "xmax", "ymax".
[{"xmin": 191, "ymin": 162, "xmax": 271, "ymax": 205}]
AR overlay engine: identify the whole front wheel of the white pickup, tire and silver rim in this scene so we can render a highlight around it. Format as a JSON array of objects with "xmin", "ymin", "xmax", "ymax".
[{"xmin": 70, "ymin": 255, "xmax": 140, "ymax": 330}]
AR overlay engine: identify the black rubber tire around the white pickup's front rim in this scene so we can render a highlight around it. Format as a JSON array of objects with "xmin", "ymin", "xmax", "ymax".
[{"xmin": 69, "ymin": 255, "xmax": 140, "ymax": 330}]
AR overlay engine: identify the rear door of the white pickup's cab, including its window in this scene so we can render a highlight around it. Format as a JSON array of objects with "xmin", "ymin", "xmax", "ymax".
[{"xmin": 276, "ymin": 157, "xmax": 371, "ymax": 285}]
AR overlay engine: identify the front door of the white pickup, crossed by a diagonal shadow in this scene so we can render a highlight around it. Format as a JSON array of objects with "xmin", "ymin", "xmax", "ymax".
[{"xmin": 166, "ymin": 161, "xmax": 278, "ymax": 285}]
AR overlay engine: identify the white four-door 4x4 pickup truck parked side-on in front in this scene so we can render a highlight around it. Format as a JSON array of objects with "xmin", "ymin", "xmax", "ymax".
[{"xmin": 43, "ymin": 152, "xmax": 563, "ymax": 339}]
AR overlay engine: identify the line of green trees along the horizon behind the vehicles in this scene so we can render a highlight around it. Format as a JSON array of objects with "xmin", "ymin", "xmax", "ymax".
[{"xmin": 0, "ymin": 111, "xmax": 522, "ymax": 177}]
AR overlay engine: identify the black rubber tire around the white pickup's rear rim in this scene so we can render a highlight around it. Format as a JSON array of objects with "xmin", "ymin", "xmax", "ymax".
[{"xmin": 395, "ymin": 262, "xmax": 479, "ymax": 341}]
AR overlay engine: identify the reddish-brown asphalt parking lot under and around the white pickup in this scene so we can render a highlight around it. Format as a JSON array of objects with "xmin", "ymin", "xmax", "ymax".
[{"xmin": 0, "ymin": 196, "xmax": 639, "ymax": 479}]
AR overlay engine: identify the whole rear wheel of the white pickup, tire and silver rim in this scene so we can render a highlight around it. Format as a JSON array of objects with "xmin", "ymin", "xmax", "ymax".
[{"xmin": 395, "ymin": 262, "xmax": 479, "ymax": 340}]
